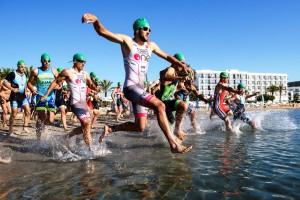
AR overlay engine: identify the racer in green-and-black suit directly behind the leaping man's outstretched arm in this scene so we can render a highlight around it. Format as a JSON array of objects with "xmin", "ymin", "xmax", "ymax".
[{"xmin": 159, "ymin": 53, "xmax": 190, "ymax": 140}]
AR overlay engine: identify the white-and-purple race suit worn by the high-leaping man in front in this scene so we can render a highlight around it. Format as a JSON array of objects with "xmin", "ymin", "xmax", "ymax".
[{"xmin": 123, "ymin": 40, "xmax": 153, "ymax": 117}]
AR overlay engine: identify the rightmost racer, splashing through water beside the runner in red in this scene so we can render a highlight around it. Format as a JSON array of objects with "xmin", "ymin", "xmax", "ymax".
[{"xmin": 227, "ymin": 83, "xmax": 259, "ymax": 129}]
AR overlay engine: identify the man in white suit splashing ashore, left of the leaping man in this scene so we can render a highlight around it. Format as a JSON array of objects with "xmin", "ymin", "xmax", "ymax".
[{"xmin": 41, "ymin": 53, "xmax": 98, "ymax": 149}]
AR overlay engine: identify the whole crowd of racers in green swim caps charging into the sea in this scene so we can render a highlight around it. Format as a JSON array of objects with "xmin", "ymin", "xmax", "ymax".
[{"xmin": 0, "ymin": 13, "xmax": 257, "ymax": 162}]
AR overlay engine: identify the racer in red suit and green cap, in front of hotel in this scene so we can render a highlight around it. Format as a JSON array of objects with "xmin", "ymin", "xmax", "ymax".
[{"xmin": 213, "ymin": 72, "xmax": 240, "ymax": 131}]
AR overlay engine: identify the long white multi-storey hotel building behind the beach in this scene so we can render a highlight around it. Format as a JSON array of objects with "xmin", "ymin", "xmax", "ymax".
[{"xmin": 195, "ymin": 70, "xmax": 288, "ymax": 102}]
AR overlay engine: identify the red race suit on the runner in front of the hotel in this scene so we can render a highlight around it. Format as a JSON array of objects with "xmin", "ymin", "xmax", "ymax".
[{"xmin": 213, "ymin": 90, "xmax": 230, "ymax": 120}]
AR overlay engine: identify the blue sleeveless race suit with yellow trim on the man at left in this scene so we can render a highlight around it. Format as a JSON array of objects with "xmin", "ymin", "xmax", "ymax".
[{"xmin": 36, "ymin": 67, "xmax": 55, "ymax": 112}]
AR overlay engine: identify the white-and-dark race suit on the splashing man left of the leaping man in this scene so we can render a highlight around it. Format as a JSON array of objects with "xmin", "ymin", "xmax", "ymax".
[{"xmin": 68, "ymin": 68, "xmax": 90, "ymax": 122}]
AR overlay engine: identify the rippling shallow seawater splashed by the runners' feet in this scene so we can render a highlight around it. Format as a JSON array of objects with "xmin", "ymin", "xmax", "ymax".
[{"xmin": 0, "ymin": 110, "xmax": 300, "ymax": 199}]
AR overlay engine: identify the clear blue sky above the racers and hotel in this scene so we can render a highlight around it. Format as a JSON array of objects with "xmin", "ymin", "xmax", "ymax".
[{"xmin": 0, "ymin": 0, "xmax": 300, "ymax": 88}]
